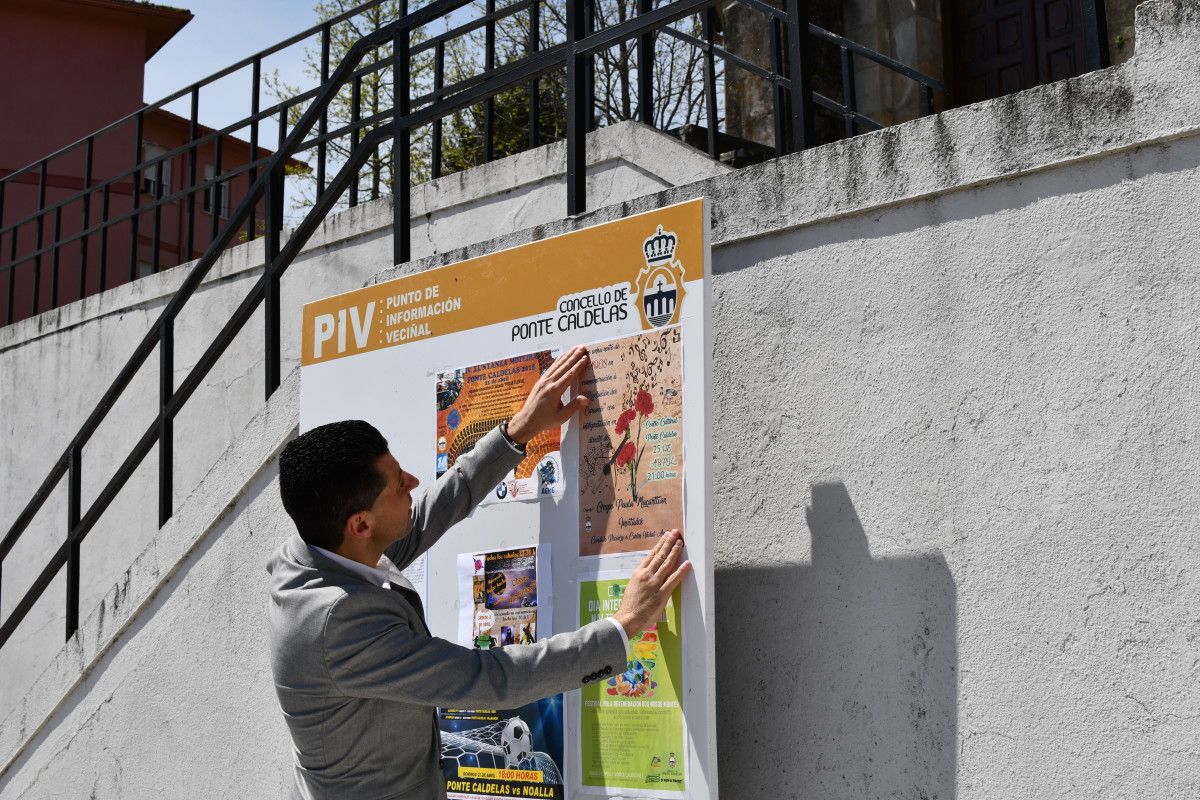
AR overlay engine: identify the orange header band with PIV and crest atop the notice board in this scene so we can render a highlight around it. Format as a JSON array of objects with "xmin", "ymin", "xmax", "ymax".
[{"xmin": 300, "ymin": 199, "xmax": 704, "ymax": 366}]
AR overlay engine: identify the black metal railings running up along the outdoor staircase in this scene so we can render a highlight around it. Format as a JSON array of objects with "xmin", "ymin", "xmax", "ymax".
[{"xmin": 0, "ymin": 0, "xmax": 941, "ymax": 646}]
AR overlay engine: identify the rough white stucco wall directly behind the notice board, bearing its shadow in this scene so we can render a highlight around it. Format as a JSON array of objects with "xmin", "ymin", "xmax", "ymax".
[{"xmin": 0, "ymin": 0, "xmax": 1200, "ymax": 800}]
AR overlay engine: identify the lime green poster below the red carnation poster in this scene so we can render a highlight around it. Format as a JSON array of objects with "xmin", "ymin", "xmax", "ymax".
[{"xmin": 580, "ymin": 578, "xmax": 684, "ymax": 792}]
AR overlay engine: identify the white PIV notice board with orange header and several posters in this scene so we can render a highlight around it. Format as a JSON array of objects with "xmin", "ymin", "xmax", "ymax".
[{"xmin": 300, "ymin": 199, "xmax": 716, "ymax": 798}]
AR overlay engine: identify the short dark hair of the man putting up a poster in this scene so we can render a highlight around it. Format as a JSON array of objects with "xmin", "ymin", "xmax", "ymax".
[{"xmin": 280, "ymin": 420, "xmax": 388, "ymax": 551}]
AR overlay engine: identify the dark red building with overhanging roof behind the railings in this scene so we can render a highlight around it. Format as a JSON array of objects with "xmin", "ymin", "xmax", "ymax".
[{"xmin": 0, "ymin": 0, "xmax": 274, "ymax": 324}]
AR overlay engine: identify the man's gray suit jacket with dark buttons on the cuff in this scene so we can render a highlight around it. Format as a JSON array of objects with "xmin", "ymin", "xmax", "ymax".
[{"xmin": 266, "ymin": 429, "xmax": 625, "ymax": 800}]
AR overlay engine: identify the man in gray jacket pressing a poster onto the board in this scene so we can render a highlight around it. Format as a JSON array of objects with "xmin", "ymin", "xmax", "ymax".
[{"xmin": 268, "ymin": 348, "xmax": 691, "ymax": 800}]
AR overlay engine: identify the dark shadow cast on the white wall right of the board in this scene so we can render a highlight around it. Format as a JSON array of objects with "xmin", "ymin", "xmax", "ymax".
[{"xmin": 716, "ymin": 483, "xmax": 958, "ymax": 800}]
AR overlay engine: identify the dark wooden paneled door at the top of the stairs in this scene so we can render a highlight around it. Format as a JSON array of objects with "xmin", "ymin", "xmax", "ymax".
[{"xmin": 943, "ymin": 0, "xmax": 1099, "ymax": 106}]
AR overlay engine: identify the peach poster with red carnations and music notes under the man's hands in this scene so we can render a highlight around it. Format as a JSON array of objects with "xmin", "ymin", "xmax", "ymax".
[{"xmin": 580, "ymin": 327, "xmax": 683, "ymax": 555}]
